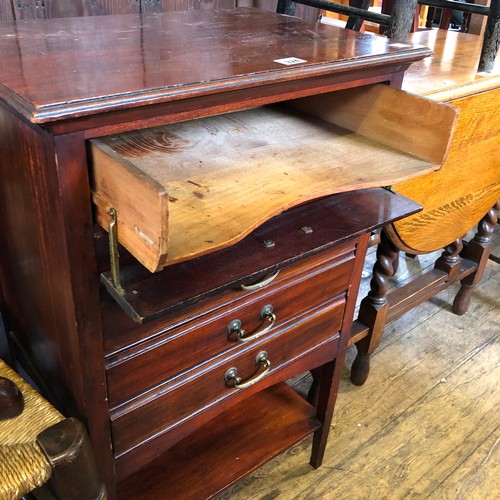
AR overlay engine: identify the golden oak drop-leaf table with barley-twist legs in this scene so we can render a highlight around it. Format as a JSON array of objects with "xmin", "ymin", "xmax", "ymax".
[{"xmin": 351, "ymin": 30, "xmax": 500, "ymax": 384}]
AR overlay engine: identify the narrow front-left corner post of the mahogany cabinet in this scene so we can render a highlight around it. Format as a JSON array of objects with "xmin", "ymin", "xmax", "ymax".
[{"xmin": 49, "ymin": 134, "xmax": 113, "ymax": 484}]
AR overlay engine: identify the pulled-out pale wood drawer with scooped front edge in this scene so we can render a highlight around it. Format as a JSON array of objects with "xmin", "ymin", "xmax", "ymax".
[{"xmin": 90, "ymin": 85, "xmax": 456, "ymax": 272}]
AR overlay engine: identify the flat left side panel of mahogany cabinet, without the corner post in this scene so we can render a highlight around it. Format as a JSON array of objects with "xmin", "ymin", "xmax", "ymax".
[{"xmin": 0, "ymin": 104, "xmax": 82, "ymax": 406}]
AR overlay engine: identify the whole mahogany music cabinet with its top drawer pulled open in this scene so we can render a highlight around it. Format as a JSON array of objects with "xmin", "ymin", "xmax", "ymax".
[{"xmin": 0, "ymin": 9, "xmax": 455, "ymax": 498}]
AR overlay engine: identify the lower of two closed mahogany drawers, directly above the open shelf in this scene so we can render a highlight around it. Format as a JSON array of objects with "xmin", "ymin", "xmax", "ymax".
[{"xmin": 111, "ymin": 298, "xmax": 345, "ymax": 456}]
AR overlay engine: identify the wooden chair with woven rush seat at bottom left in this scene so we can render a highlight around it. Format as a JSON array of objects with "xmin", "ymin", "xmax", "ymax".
[{"xmin": 0, "ymin": 360, "xmax": 106, "ymax": 500}]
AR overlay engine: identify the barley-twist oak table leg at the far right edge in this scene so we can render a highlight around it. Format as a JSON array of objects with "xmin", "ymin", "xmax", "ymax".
[{"xmin": 453, "ymin": 200, "xmax": 500, "ymax": 315}]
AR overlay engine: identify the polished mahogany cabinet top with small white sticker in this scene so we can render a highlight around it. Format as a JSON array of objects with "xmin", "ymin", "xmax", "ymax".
[{"xmin": 0, "ymin": 9, "xmax": 430, "ymax": 123}]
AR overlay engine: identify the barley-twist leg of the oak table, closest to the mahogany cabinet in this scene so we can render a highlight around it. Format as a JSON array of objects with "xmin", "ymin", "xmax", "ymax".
[{"xmin": 351, "ymin": 231, "xmax": 399, "ymax": 385}]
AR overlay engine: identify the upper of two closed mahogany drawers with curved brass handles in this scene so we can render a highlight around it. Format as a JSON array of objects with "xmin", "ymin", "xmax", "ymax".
[{"xmin": 107, "ymin": 246, "xmax": 354, "ymax": 408}]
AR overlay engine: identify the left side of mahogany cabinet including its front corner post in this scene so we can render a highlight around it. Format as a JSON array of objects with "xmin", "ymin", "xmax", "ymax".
[{"xmin": 0, "ymin": 107, "xmax": 111, "ymax": 488}]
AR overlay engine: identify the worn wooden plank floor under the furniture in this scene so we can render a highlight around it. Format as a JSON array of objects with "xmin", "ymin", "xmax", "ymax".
[{"xmin": 220, "ymin": 226, "xmax": 500, "ymax": 500}]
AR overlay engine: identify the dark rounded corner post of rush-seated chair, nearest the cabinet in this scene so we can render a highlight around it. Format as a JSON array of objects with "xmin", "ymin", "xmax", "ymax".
[{"xmin": 37, "ymin": 418, "xmax": 107, "ymax": 500}]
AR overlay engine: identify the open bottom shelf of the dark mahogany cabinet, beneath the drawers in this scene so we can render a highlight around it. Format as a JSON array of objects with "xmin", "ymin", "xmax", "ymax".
[{"xmin": 118, "ymin": 383, "xmax": 320, "ymax": 500}]
